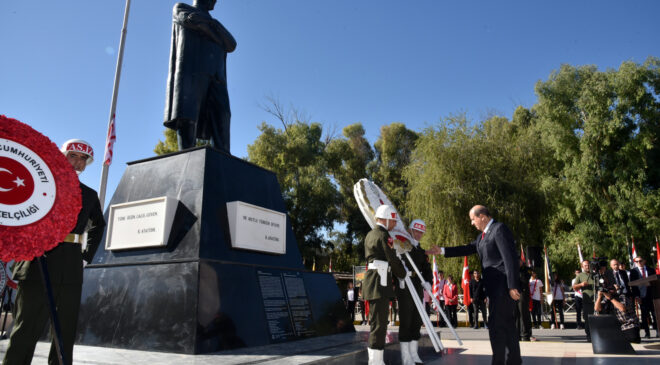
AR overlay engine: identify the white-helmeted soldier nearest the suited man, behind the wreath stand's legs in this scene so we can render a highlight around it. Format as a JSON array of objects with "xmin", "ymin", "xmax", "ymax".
[{"xmin": 396, "ymin": 219, "xmax": 433, "ymax": 365}]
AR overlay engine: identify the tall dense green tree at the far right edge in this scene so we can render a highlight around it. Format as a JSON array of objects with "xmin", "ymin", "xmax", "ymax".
[{"xmin": 533, "ymin": 58, "xmax": 660, "ymax": 259}]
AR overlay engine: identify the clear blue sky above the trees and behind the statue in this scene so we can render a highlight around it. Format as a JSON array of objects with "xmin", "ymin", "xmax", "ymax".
[{"xmin": 0, "ymin": 0, "xmax": 660, "ymax": 206}]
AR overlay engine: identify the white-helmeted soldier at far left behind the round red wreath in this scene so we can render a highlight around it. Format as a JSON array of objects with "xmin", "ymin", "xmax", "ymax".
[{"xmin": 3, "ymin": 139, "xmax": 105, "ymax": 365}]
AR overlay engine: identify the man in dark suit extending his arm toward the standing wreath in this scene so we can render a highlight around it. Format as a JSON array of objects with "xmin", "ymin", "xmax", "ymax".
[{"xmin": 440, "ymin": 205, "xmax": 522, "ymax": 365}]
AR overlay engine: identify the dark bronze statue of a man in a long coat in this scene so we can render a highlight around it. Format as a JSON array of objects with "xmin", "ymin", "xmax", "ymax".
[{"xmin": 163, "ymin": 0, "xmax": 236, "ymax": 153}]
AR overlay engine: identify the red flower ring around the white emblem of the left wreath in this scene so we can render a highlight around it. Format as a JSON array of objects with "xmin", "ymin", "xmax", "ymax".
[{"xmin": 0, "ymin": 115, "xmax": 82, "ymax": 262}]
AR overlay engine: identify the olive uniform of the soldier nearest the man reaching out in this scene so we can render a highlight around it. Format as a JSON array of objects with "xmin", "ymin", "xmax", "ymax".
[{"xmin": 396, "ymin": 242, "xmax": 433, "ymax": 342}]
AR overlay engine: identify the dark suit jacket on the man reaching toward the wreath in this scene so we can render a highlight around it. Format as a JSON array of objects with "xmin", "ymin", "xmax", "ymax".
[{"xmin": 445, "ymin": 221, "xmax": 520, "ymax": 295}]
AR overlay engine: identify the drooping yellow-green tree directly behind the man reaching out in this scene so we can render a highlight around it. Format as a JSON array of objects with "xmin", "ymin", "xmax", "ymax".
[{"xmin": 404, "ymin": 111, "xmax": 551, "ymax": 273}]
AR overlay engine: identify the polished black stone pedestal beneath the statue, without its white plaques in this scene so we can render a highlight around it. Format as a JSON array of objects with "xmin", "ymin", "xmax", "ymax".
[{"xmin": 78, "ymin": 147, "xmax": 354, "ymax": 354}]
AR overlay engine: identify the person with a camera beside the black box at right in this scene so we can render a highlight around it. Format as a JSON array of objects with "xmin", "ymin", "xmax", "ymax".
[{"xmin": 594, "ymin": 259, "xmax": 641, "ymax": 343}]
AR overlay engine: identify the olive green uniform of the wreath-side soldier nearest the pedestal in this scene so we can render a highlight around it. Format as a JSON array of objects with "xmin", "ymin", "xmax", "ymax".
[{"xmin": 362, "ymin": 225, "xmax": 406, "ymax": 350}]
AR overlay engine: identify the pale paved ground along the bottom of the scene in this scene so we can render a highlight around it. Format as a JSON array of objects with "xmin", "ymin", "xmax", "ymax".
[{"xmin": 0, "ymin": 326, "xmax": 660, "ymax": 365}]
